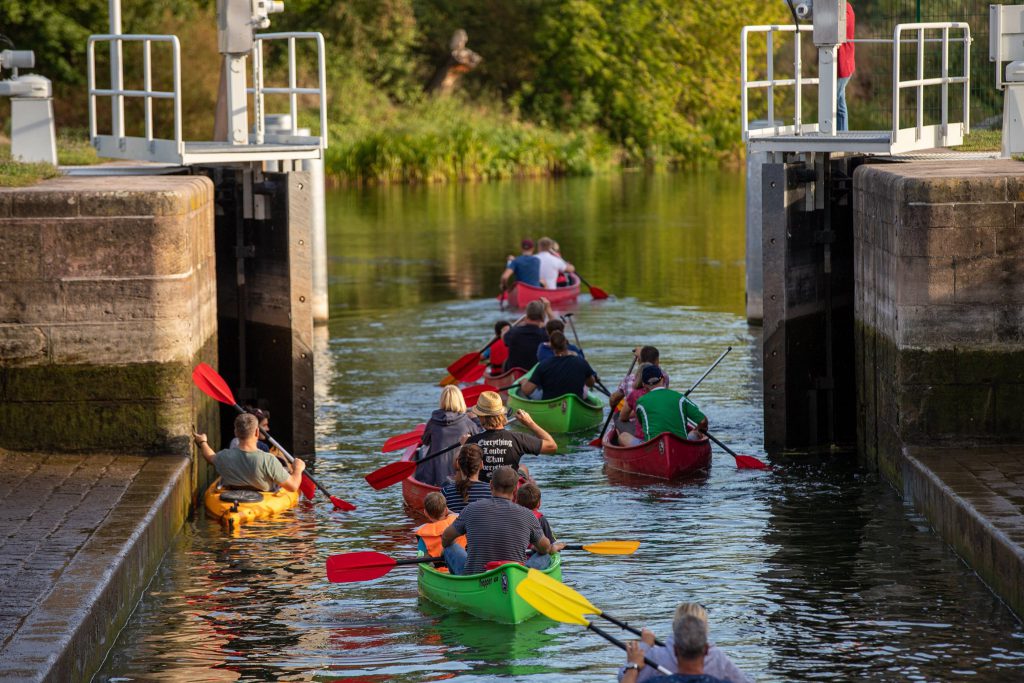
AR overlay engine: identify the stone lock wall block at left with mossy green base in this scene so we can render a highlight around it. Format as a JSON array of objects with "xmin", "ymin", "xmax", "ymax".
[{"xmin": 0, "ymin": 176, "xmax": 219, "ymax": 455}]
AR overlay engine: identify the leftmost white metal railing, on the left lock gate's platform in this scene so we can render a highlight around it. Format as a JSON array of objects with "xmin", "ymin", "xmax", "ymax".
[{"xmin": 87, "ymin": 34, "xmax": 184, "ymax": 153}]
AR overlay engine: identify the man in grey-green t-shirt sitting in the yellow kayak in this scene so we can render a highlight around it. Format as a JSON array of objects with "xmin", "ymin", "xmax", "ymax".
[{"xmin": 194, "ymin": 413, "xmax": 306, "ymax": 490}]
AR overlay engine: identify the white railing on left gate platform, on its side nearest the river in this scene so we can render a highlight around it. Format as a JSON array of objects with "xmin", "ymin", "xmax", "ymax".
[{"xmin": 247, "ymin": 32, "xmax": 328, "ymax": 148}]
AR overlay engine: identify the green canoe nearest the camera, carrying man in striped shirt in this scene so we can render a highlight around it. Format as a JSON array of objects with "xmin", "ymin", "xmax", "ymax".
[{"xmin": 419, "ymin": 554, "xmax": 562, "ymax": 624}]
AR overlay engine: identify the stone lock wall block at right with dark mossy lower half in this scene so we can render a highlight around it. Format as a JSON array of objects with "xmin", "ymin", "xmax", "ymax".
[{"xmin": 854, "ymin": 160, "xmax": 1024, "ymax": 482}]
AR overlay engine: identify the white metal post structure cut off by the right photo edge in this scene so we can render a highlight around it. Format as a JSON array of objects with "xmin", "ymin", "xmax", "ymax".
[{"xmin": 988, "ymin": 5, "xmax": 1024, "ymax": 157}]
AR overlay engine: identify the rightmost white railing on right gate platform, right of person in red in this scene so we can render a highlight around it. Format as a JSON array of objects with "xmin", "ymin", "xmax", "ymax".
[{"xmin": 893, "ymin": 22, "xmax": 971, "ymax": 140}]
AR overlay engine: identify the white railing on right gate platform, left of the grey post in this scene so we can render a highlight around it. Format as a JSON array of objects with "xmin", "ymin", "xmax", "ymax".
[{"xmin": 739, "ymin": 24, "xmax": 818, "ymax": 140}]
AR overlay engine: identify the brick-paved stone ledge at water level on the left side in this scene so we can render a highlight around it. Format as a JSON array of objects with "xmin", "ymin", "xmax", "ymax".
[{"xmin": 0, "ymin": 456, "xmax": 193, "ymax": 681}]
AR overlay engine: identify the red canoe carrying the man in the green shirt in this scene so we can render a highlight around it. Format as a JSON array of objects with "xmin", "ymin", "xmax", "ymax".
[{"xmin": 602, "ymin": 429, "xmax": 711, "ymax": 479}]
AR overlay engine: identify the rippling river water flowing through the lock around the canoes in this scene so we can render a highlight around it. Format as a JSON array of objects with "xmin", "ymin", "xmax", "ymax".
[{"xmin": 98, "ymin": 173, "xmax": 1024, "ymax": 682}]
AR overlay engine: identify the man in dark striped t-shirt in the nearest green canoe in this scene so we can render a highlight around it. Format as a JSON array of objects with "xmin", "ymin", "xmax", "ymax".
[{"xmin": 441, "ymin": 467, "xmax": 553, "ymax": 574}]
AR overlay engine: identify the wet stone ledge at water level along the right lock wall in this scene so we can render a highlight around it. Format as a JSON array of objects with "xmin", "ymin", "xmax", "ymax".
[{"xmin": 902, "ymin": 445, "xmax": 1024, "ymax": 618}]
